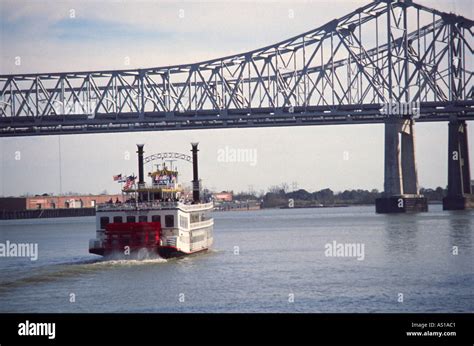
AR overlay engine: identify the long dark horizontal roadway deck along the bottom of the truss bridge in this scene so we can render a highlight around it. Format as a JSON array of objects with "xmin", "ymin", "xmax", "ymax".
[{"xmin": 0, "ymin": 100, "xmax": 474, "ymax": 137}]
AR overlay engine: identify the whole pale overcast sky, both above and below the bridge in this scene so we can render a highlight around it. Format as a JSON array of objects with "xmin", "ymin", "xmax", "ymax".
[{"xmin": 0, "ymin": 0, "xmax": 474, "ymax": 196}]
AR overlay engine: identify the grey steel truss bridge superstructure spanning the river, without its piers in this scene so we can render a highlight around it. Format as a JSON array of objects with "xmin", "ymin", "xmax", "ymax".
[{"xmin": 0, "ymin": 0, "xmax": 474, "ymax": 136}]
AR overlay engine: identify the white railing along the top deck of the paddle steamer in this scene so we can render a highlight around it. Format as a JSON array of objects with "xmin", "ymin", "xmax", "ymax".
[{"xmin": 96, "ymin": 202, "xmax": 214, "ymax": 211}]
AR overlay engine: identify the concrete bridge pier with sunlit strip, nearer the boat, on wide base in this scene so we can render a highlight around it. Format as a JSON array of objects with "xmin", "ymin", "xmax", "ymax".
[{"xmin": 375, "ymin": 118, "xmax": 428, "ymax": 213}]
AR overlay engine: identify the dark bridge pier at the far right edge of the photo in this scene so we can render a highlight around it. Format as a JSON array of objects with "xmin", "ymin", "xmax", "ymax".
[{"xmin": 443, "ymin": 117, "xmax": 474, "ymax": 210}]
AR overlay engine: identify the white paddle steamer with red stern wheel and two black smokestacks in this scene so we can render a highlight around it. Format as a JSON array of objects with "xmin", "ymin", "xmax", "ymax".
[{"xmin": 89, "ymin": 143, "xmax": 214, "ymax": 259}]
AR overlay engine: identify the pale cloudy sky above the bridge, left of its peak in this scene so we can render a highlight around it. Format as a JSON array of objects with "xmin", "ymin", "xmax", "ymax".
[{"xmin": 0, "ymin": 0, "xmax": 362, "ymax": 73}]
